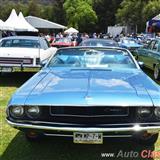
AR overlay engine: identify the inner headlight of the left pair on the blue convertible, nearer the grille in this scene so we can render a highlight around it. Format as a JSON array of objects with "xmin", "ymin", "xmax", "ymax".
[{"xmin": 27, "ymin": 106, "xmax": 40, "ymax": 118}]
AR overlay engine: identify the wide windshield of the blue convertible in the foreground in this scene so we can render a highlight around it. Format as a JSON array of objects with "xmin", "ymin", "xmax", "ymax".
[{"xmin": 48, "ymin": 49, "xmax": 136, "ymax": 68}]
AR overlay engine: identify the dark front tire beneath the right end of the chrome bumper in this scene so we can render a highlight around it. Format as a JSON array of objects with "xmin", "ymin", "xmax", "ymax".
[{"xmin": 134, "ymin": 132, "xmax": 159, "ymax": 146}]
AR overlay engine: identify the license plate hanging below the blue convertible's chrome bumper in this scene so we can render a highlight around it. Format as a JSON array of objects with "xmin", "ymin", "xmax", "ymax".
[{"xmin": 73, "ymin": 132, "xmax": 103, "ymax": 144}]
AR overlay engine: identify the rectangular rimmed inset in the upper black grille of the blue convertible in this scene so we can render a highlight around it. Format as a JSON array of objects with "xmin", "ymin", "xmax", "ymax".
[{"xmin": 50, "ymin": 106, "xmax": 129, "ymax": 117}]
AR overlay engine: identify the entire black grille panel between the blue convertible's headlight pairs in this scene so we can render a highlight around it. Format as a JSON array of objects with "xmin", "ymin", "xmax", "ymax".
[{"xmin": 16, "ymin": 106, "xmax": 136, "ymax": 126}]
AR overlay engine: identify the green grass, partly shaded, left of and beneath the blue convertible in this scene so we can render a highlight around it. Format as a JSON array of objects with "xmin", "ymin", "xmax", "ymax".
[{"xmin": 0, "ymin": 73, "xmax": 160, "ymax": 160}]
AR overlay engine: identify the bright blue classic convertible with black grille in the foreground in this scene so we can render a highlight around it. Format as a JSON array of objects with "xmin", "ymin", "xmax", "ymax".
[{"xmin": 7, "ymin": 47, "xmax": 160, "ymax": 144}]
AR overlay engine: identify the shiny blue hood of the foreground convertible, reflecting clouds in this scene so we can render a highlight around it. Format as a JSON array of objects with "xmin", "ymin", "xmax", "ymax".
[{"xmin": 11, "ymin": 69, "xmax": 159, "ymax": 106}]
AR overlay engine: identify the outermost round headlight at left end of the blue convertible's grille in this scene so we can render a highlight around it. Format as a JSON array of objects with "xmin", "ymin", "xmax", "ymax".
[{"xmin": 10, "ymin": 106, "xmax": 24, "ymax": 118}]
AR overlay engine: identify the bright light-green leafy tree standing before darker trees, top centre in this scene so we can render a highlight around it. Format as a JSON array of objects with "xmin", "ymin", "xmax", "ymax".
[{"xmin": 64, "ymin": 0, "xmax": 97, "ymax": 32}]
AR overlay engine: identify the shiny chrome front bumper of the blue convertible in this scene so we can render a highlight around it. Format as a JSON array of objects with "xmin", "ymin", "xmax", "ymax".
[{"xmin": 7, "ymin": 120, "xmax": 160, "ymax": 133}]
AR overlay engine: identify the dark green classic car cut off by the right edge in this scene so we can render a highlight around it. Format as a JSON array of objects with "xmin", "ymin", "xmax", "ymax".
[{"xmin": 136, "ymin": 39, "xmax": 160, "ymax": 80}]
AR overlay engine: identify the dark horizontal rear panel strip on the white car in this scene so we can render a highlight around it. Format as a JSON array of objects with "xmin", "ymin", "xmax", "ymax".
[{"xmin": 0, "ymin": 57, "xmax": 33, "ymax": 64}]
